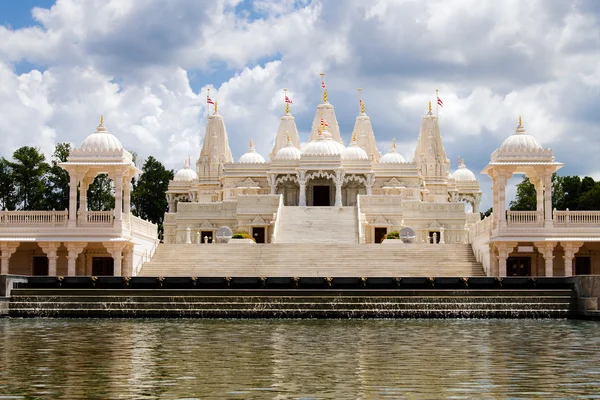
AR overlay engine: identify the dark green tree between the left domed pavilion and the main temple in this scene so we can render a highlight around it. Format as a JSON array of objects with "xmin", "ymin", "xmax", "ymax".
[{"xmin": 131, "ymin": 156, "xmax": 173, "ymax": 236}]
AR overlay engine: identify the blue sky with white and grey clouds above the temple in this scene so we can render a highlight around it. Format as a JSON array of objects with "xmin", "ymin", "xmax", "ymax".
[{"xmin": 0, "ymin": 0, "xmax": 600, "ymax": 208}]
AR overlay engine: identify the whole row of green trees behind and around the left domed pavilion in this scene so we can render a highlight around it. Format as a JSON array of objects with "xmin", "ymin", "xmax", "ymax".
[{"xmin": 0, "ymin": 143, "xmax": 173, "ymax": 235}]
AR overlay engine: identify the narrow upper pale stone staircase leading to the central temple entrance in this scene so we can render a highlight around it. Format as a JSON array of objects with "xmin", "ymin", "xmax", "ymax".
[{"xmin": 276, "ymin": 206, "xmax": 358, "ymax": 243}]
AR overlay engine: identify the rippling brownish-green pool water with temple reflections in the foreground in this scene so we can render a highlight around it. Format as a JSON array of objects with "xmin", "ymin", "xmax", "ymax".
[{"xmin": 0, "ymin": 319, "xmax": 600, "ymax": 399}]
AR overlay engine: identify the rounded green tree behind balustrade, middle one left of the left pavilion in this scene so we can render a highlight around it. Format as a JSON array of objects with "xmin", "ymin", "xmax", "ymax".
[{"xmin": 8, "ymin": 146, "xmax": 50, "ymax": 210}]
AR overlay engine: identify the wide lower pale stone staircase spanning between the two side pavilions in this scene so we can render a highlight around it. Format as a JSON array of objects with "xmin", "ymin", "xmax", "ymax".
[{"xmin": 139, "ymin": 242, "xmax": 484, "ymax": 277}]
